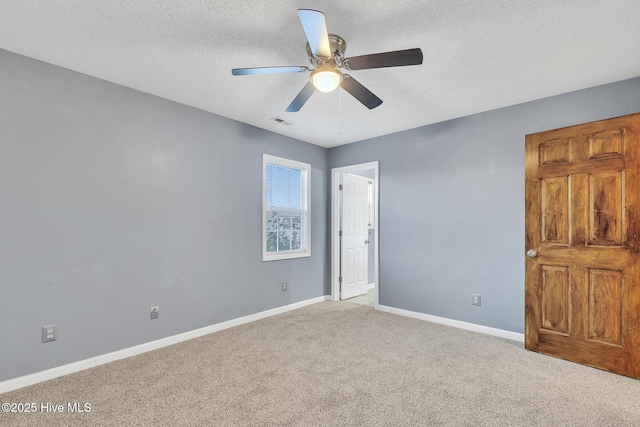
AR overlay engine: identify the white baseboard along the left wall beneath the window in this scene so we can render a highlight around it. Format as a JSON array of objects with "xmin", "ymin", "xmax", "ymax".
[{"xmin": 0, "ymin": 296, "xmax": 330, "ymax": 394}]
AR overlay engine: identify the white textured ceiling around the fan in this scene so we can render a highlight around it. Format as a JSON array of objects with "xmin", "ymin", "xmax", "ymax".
[{"xmin": 0, "ymin": 0, "xmax": 640, "ymax": 147}]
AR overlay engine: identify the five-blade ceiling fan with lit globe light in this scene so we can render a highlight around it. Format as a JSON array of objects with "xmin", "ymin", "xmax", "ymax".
[{"xmin": 231, "ymin": 9, "xmax": 422, "ymax": 113}]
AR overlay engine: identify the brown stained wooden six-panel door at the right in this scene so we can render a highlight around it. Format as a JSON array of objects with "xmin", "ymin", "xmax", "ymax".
[{"xmin": 525, "ymin": 114, "xmax": 640, "ymax": 378}]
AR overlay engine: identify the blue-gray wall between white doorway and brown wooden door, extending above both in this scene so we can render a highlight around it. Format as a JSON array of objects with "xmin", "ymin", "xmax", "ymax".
[{"xmin": 329, "ymin": 78, "xmax": 640, "ymax": 332}]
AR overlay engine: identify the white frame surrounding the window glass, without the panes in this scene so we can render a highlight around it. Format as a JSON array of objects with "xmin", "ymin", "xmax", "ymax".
[{"xmin": 261, "ymin": 154, "xmax": 311, "ymax": 261}]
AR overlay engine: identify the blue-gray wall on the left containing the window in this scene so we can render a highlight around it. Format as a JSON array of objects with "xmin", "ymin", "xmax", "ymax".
[{"xmin": 0, "ymin": 50, "xmax": 329, "ymax": 381}]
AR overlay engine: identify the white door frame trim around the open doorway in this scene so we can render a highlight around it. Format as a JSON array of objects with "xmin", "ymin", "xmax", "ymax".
[{"xmin": 330, "ymin": 160, "xmax": 380, "ymax": 310}]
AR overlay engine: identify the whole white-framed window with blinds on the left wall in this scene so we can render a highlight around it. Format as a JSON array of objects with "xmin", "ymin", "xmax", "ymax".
[{"xmin": 262, "ymin": 154, "xmax": 311, "ymax": 261}]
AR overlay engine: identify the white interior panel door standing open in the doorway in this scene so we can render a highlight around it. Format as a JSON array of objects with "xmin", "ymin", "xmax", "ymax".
[{"xmin": 340, "ymin": 174, "xmax": 369, "ymax": 299}]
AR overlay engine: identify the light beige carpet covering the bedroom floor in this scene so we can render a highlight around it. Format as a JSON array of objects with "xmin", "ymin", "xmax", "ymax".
[{"xmin": 0, "ymin": 302, "xmax": 640, "ymax": 427}]
